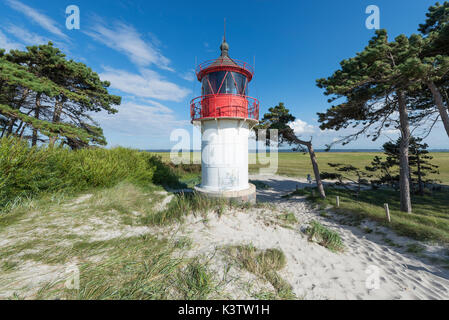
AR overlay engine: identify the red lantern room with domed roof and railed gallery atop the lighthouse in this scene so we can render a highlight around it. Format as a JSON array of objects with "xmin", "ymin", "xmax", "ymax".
[{"xmin": 190, "ymin": 35, "xmax": 259, "ymax": 122}]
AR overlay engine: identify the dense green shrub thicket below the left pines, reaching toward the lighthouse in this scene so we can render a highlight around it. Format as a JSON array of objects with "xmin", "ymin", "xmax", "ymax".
[{"xmin": 0, "ymin": 137, "xmax": 179, "ymax": 208}]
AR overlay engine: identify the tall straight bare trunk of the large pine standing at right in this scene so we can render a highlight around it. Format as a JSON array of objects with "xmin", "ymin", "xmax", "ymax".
[{"xmin": 398, "ymin": 92, "xmax": 412, "ymax": 213}]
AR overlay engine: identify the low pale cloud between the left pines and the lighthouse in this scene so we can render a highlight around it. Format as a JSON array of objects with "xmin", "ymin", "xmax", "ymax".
[{"xmin": 93, "ymin": 101, "xmax": 189, "ymax": 138}]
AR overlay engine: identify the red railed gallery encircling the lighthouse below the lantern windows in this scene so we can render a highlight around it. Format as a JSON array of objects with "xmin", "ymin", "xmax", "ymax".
[{"xmin": 190, "ymin": 94, "xmax": 259, "ymax": 121}]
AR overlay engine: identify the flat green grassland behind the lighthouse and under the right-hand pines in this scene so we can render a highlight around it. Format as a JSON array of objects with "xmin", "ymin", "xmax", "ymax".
[{"xmin": 152, "ymin": 152, "xmax": 449, "ymax": 244}]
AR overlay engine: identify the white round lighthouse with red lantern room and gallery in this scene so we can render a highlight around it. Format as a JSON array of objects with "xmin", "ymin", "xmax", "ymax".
[{"xmin": 190, "ymin": 34, "xmax": 259, "ymax": 203}]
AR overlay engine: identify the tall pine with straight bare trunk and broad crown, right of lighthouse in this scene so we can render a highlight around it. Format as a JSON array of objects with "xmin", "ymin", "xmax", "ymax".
[{"xmin": 317, "ymin": 30, "xmax": 423, "ymax": 213}]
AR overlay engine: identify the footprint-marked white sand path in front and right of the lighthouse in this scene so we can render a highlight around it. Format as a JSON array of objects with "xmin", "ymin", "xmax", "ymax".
[{"xmin": 174, "ymin": 176, "xmax": 449, "ymax": 299}]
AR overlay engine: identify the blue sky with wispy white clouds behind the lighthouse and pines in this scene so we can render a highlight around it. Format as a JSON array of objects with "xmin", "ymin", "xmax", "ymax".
[{"xmin": 0, "ymin": 0, "xmax": 449, "ymax": 149}]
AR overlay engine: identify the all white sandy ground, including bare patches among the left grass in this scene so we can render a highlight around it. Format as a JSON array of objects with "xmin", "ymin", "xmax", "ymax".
[{"xmin": 0, "ymin": 176, "xmax": 449, "ymax": 299}]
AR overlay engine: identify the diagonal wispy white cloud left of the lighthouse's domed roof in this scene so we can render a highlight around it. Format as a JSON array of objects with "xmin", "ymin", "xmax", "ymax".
[{"xmin": 86, "ymin": 23, "xmax": 173, "ymax": 71}]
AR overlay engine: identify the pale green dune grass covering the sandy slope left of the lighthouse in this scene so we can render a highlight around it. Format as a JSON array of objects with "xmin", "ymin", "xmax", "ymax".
[{"xmin": 0, "ymin": 182, "xmax": 228, "ymax": 300}]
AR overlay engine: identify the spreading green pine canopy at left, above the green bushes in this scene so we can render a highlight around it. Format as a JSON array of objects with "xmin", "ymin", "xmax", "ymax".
[{"xmin": 0, "ymin": 42, "xmax": 121, "ymax": 148}]
